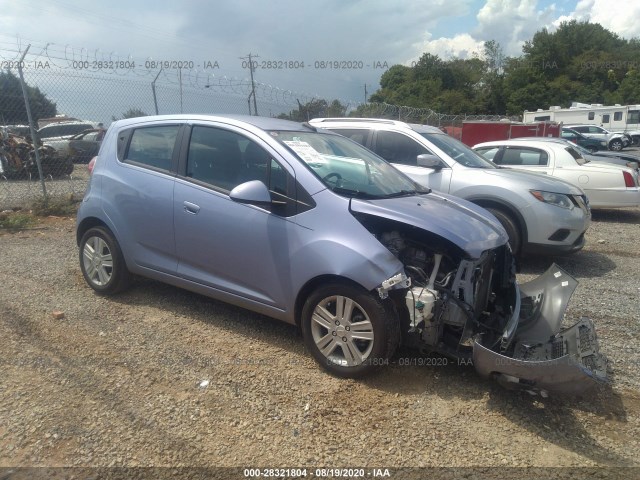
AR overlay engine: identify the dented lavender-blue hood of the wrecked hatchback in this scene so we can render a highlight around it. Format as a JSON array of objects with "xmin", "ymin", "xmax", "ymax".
[{"xmin": 349, "ymin": 192, "xmax": 508, "ymax": 258}]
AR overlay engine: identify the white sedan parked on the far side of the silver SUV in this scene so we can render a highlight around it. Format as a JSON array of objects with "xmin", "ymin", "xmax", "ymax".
[{"xmin": 473, "ymin": 139, "xmax": 640, "ymax": 208}]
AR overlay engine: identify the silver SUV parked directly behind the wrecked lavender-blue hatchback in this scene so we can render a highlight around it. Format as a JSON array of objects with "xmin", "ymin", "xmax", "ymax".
[{"xmin": 310, "ymin": 118, "xmax": 591, "ymax": 255}]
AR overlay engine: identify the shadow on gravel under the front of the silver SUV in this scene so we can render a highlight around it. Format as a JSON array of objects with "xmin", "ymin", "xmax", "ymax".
[{"xmin": 518, "ymin": 250, "xmax": 616, "ymax": 279}]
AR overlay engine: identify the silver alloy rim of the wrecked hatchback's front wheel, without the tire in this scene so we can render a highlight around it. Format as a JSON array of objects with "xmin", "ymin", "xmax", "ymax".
[{"xmin": 311, "ymin": 295, "xmax": 374, "ymax": 367}]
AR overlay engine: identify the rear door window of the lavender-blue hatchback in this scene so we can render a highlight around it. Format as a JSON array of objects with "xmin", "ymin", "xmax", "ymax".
[{"xmin": 125, "ymin": 125, "xmax": 180, "ymax": 171}]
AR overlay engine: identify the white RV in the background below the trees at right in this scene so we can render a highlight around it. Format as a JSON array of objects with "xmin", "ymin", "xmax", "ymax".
[{"xmin": 523, "ymin": 102, "xmax": 640, "ymax": 144}]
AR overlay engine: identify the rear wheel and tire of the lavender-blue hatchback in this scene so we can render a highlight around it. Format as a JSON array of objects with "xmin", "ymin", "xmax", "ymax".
[{"xmin": 80, "ymin": 227, "xmax": 131, "ymax": 295}]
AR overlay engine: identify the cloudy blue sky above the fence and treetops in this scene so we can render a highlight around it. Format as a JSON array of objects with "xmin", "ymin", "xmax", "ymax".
[{"xmin": 0, "ymin": 0, "xmax": 640, "ymax": 106}]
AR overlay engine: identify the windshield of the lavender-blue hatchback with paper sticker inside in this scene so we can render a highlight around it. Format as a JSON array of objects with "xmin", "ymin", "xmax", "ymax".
[{"xmin": 270, "ymin": 131, "xmax": 430, "ymax": 199}]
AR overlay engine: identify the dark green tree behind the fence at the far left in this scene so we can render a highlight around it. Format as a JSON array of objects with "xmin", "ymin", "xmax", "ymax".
[{"xmin": 0, "ymin": 70, "xmax": 58, "ymax": 125}]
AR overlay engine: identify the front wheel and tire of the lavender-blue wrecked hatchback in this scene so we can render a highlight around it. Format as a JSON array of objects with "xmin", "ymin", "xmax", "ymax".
[{"xmin": 301, "ymin": 283, "xmax": 400, "ymax": 378}]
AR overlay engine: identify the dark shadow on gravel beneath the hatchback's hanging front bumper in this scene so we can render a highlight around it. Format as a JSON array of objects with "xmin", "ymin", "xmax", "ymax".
[{"xmin": 362, "ymin": 350, "xmax": 635, "ymax": 466}]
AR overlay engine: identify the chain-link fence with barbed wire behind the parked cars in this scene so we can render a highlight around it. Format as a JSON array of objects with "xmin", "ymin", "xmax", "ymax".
[{"xmin": 0, "ymin": 44, "xmax": 516, "ymax": 209}]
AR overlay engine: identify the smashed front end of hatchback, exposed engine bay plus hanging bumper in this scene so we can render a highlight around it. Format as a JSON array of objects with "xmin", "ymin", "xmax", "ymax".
[{"xmin": 374, "ymin": 230, "xmax": 606, "ymax": 394}]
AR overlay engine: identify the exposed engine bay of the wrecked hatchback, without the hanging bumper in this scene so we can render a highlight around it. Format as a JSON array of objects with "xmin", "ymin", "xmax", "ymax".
[{"xmin": 379, "ymin": 230, "xmax": 518, "ymax": 357}]
